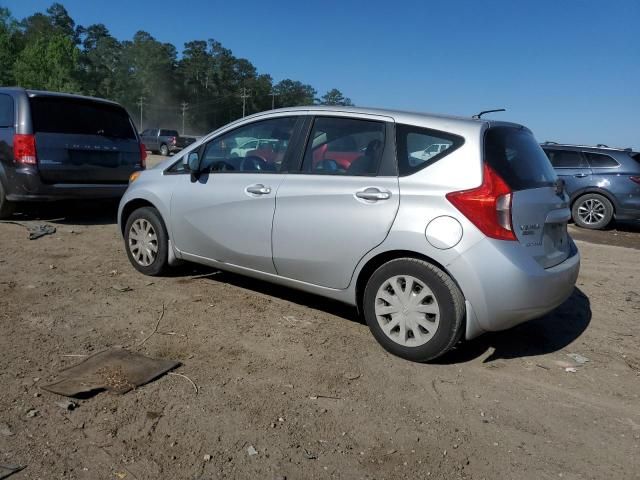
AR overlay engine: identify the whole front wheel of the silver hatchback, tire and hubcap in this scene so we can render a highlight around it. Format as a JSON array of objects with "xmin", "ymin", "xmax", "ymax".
[{"xmin": 124, "ymin": 207, "xmax": 169, "ymax": 276}]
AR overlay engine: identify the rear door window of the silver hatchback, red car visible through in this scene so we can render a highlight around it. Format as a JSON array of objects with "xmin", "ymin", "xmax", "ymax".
[{"xmin": 302, "ymin": 117, "xmax": 386, "ymax": 176}]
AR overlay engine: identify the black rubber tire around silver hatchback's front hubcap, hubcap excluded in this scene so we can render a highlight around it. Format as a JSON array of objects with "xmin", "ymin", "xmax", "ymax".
[{"xmin": 124, "ymin": 207, "xmax": 169, "ymax": 276}]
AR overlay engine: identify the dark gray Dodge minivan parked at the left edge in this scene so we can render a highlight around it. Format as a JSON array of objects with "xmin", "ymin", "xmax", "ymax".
[{"xmin": 0, "ymin": 87, "xmax": 146, "ymax": 217}]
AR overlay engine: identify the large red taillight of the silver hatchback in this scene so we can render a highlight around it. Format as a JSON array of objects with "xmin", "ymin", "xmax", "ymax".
[{"xmin": 447, "ymin": 163, "xmax": 516, "ymax": 240}]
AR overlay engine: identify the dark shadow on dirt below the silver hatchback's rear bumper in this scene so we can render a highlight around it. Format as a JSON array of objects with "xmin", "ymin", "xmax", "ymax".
[{"xmin": 432, "ymin": 287, "xmax": 591, "ymax": 365}]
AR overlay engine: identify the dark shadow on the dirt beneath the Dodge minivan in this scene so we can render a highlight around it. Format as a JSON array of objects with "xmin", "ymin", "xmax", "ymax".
[{"xmin": 7, "ymin": 200, "xmax": 119, "ymax": 225}]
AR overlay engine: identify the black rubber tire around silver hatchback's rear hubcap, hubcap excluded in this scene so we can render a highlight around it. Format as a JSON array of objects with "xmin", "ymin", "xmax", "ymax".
[{"xmin": 362, "ymin": 258, "xmax": 465, "ymax": 362}]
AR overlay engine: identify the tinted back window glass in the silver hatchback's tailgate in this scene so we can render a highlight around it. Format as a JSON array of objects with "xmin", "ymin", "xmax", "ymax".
[{"xmin": 484, "ymin": 127, "xmax": 557, "ymax": 190}]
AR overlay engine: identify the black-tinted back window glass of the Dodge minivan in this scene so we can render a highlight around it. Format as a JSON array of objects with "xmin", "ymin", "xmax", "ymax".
[{"xmin": 29, "ymin": 97, "xmax": 136, "ymax": 140}]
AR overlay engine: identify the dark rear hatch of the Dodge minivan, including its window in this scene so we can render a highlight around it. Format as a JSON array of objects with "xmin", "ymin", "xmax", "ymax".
[{"xmin": 29, "ymin": 95, "xmax": 142, "ymax": 184}]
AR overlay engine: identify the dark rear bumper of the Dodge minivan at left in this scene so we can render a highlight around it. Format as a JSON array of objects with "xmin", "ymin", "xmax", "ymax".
[{"xmin": 6, "ymin": 168, "xmax": 128, "ymax": 202}]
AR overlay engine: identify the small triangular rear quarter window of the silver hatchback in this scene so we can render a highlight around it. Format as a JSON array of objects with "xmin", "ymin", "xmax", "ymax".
[{"xmin": 396, "ymin": 125, "xmax": 464, "ymax": 176}]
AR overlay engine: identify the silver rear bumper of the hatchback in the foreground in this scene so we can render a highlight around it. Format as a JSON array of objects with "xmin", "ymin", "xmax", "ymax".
[{"xmin": 448, "ymin": 239, "xmax": 580, "ymax": 339}]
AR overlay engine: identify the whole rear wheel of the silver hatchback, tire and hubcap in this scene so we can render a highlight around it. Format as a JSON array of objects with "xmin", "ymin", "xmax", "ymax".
[{"xmin": 362, "ymin": 258, "xmax": 464, "ymax": 362}]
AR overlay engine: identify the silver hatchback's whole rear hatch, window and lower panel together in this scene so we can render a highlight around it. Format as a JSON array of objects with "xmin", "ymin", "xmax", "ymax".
[{"xmin": 484, "ymin": 126, "xmax": 571, "ymax": 268}]
